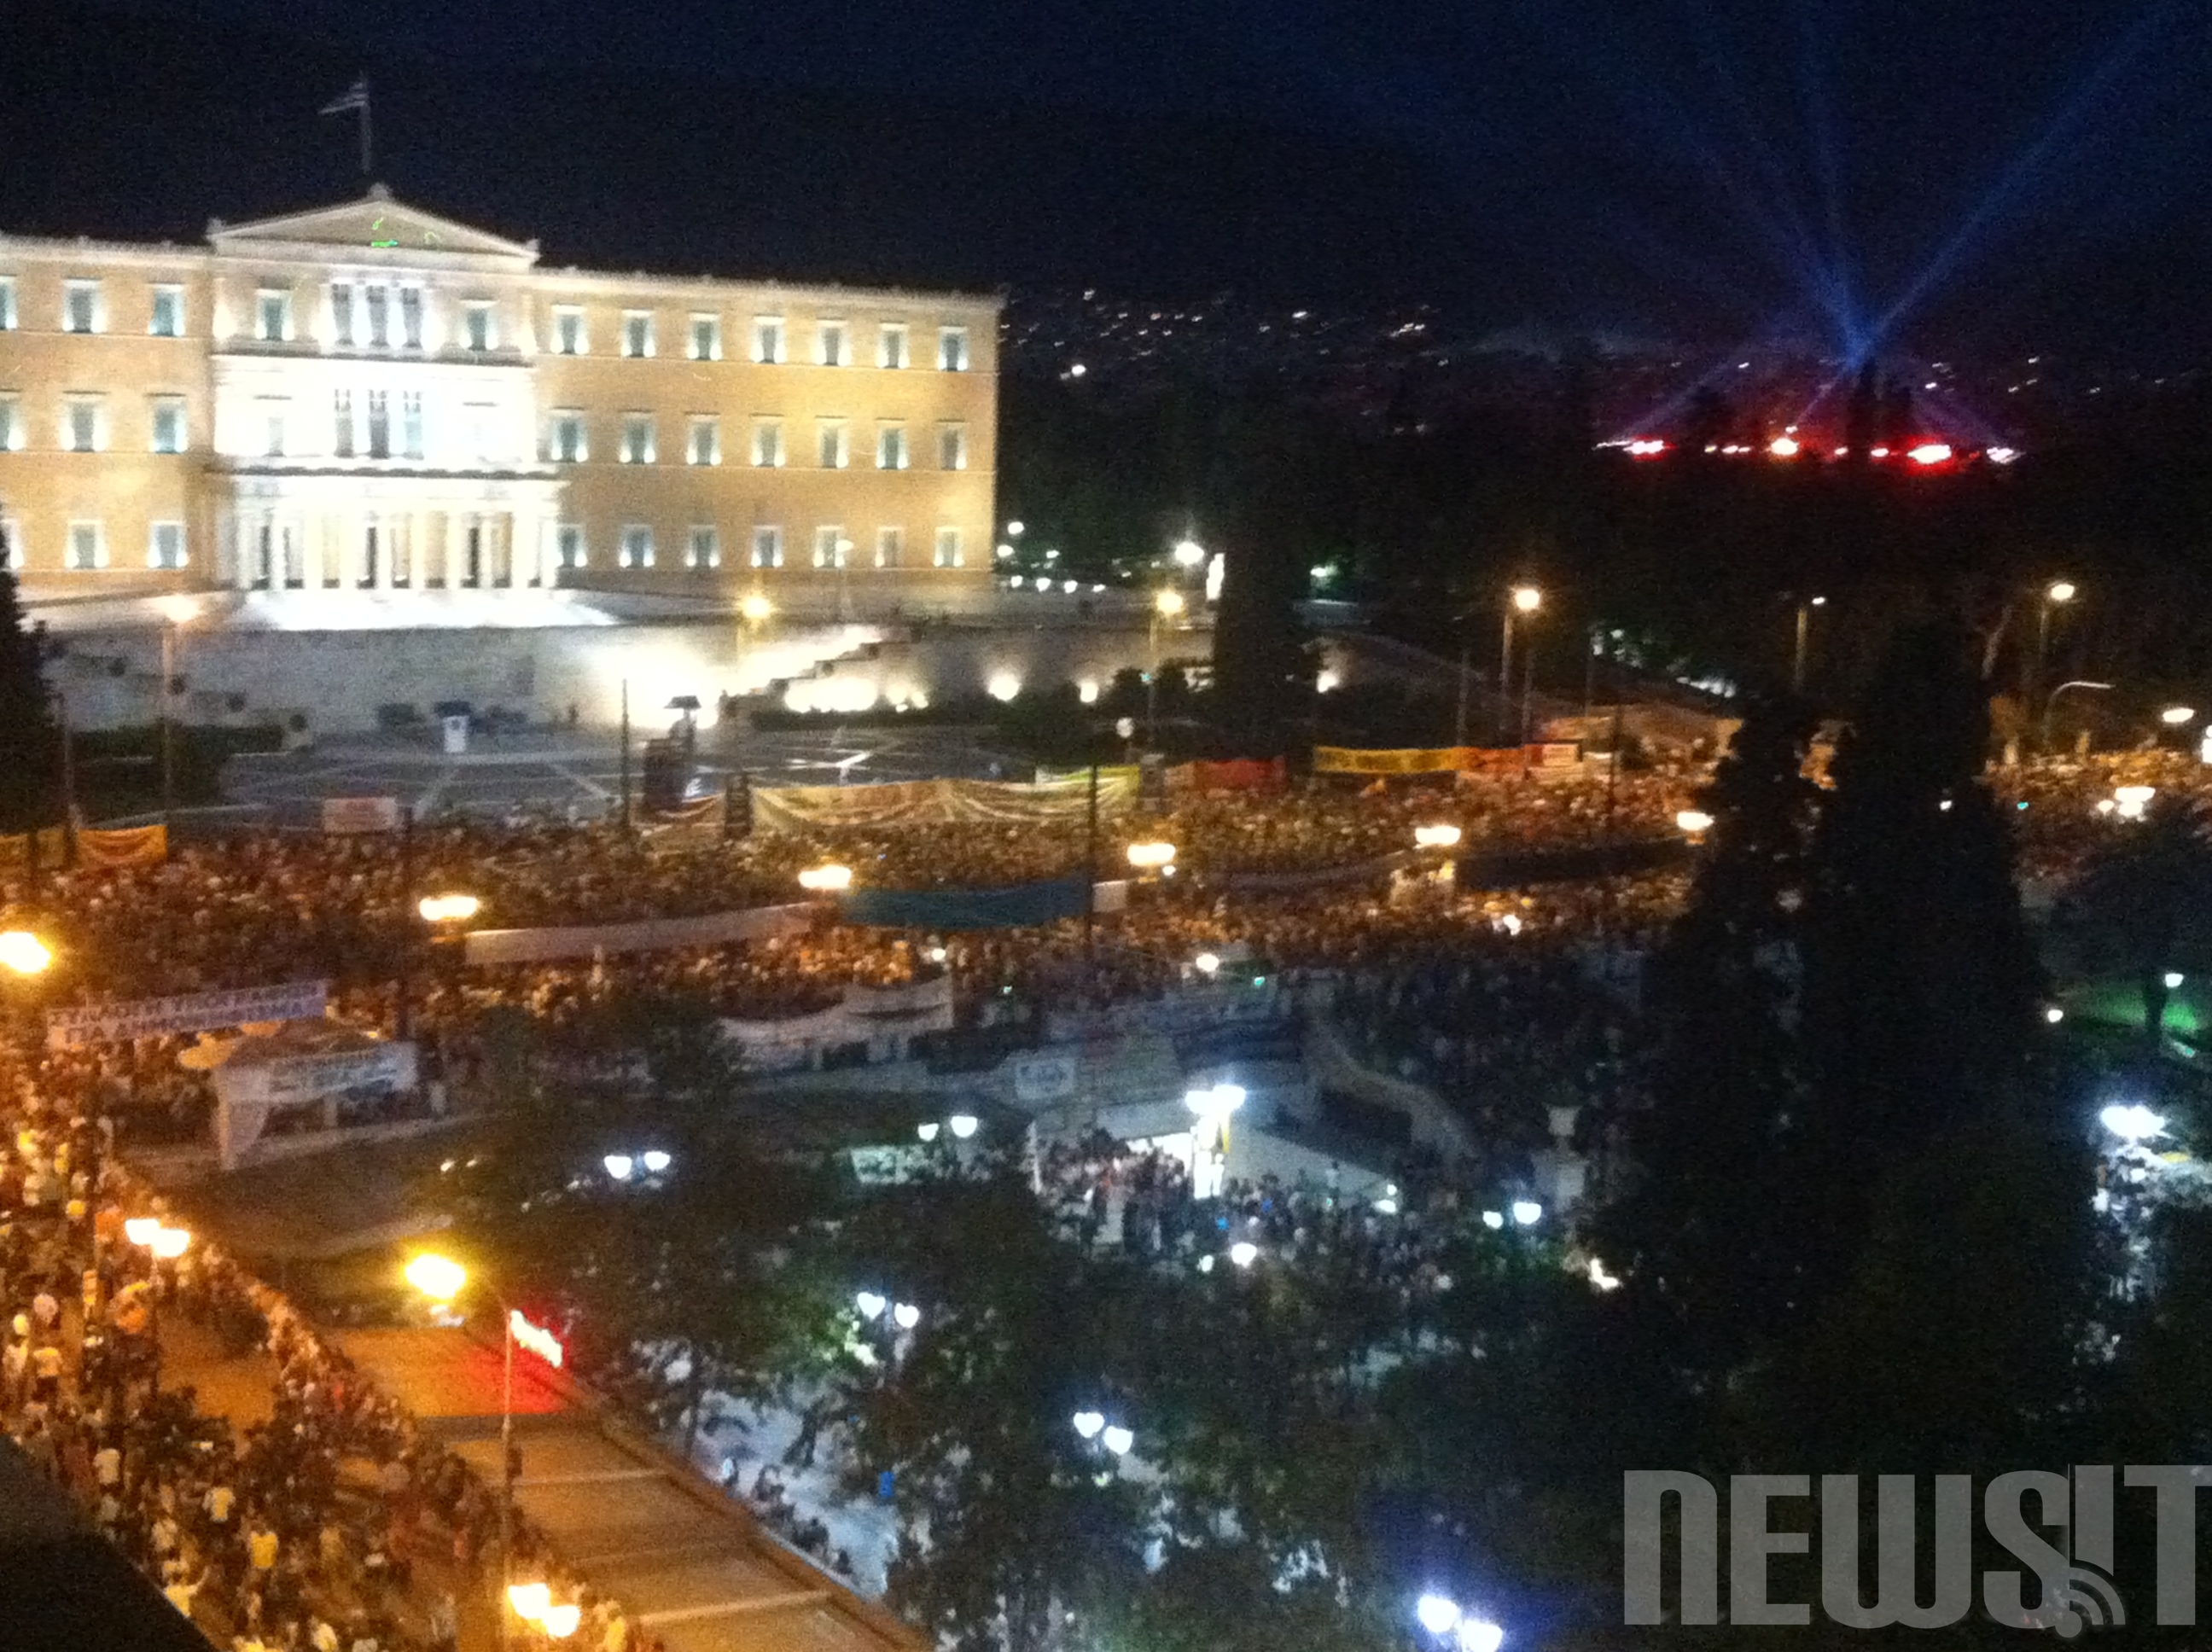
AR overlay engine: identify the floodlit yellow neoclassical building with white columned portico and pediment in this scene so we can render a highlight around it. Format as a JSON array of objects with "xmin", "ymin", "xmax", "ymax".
[{"xmin": 0, "ymin": 188, "xmax": 1000, "ymax": 624}]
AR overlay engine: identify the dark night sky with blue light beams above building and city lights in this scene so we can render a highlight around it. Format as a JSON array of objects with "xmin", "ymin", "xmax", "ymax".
[{"xmin": 0, "ymin": 0, "xmax": 2212, "ymax": 360}]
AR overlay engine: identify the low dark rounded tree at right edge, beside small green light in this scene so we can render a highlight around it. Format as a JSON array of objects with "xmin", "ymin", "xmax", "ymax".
[{"xmin": 2059, "ymin": 796, "xmax": 2212, "ymax": 1062}]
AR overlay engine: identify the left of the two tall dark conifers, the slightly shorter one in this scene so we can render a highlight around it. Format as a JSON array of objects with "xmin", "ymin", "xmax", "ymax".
[{"xmin": 1595, "ymin": 695, "xmax": 1820, "ymax": 1376}]
